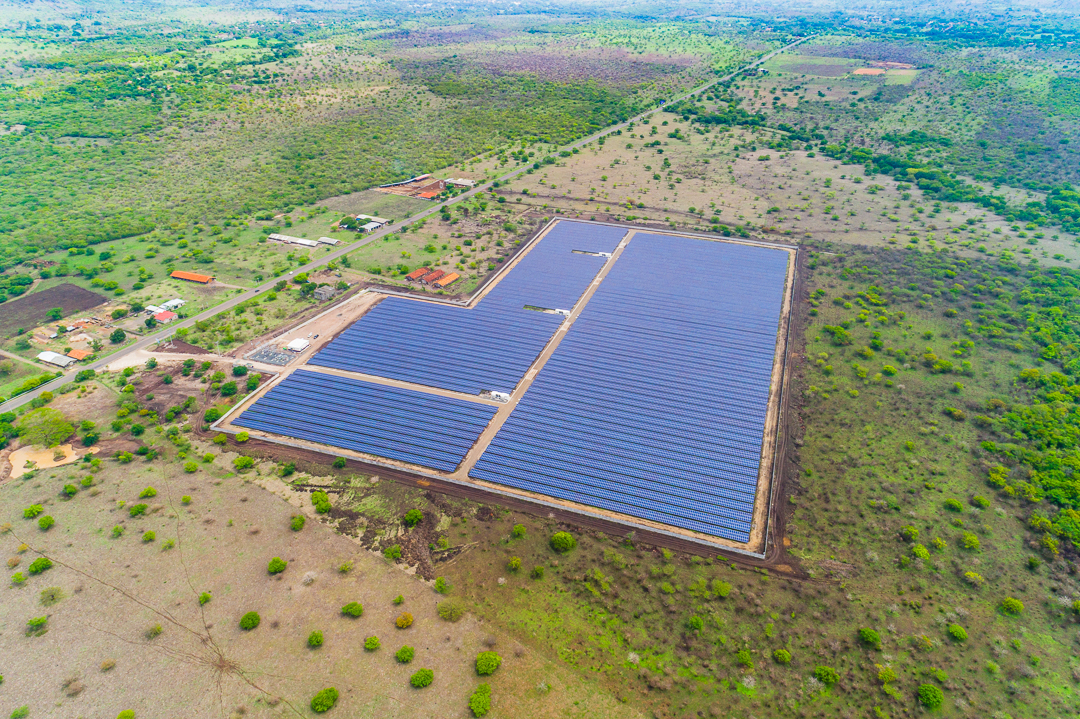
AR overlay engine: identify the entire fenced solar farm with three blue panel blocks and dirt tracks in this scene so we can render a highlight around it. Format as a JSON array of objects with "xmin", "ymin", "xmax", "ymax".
[{"xmin": 219, "ymin": 220, "xmax": 795, "ymax": 554}]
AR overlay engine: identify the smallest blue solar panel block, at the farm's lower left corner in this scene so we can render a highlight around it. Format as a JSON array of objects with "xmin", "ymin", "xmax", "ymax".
[{"xmin": 233, "ymin": 369, "xmax": 497, "ymax": 472}]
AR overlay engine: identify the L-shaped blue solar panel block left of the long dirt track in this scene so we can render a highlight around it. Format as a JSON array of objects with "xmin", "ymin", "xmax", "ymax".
[{"xmin": 309, "ymin": 220, "xmax": 626, "ymax": 394}]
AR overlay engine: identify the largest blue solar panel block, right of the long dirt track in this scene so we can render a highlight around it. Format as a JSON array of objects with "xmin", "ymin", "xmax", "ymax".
[{"xmin": 471, "ymin": 233, "xmax": 788, "ymax": 542}]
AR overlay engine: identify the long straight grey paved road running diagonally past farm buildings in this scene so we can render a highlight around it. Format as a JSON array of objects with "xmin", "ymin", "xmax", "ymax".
[{"xmin": 0, "ymin": 36, "xmax": 814, "ymax": 411}]
